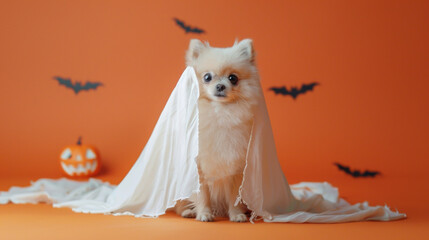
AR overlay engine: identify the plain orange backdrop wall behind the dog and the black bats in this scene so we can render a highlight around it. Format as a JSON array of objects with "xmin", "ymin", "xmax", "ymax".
[{"xmin": 0, "ymin": 0, "xmax": 429, "ymax": 239}]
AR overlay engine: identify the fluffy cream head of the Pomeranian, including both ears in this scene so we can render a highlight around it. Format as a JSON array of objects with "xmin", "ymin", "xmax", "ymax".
[{"xmin": 186, "ymin": 39, "xmax": 259, "ymax": 103}]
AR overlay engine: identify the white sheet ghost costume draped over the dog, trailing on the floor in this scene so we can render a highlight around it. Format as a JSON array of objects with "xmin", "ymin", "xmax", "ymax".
[{"xmin": 0, "ymin": 67, "xmax": 406, "ymax": 223}]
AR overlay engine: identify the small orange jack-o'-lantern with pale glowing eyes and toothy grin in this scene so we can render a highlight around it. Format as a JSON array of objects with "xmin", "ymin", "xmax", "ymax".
[{"xmin": 60, "ymin": 137, "xmax": 101, "ymax": 177}]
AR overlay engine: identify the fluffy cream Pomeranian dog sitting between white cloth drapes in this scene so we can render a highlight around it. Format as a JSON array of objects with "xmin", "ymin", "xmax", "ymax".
[{"xmin": 175, "ymin": 39, "xmax": 261, "ymax": 222}]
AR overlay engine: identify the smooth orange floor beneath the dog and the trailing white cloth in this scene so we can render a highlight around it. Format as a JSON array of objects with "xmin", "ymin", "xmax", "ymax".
[{"xmin": 0, "ymin": 176, "xmax": 429, "ymax": 240}]
